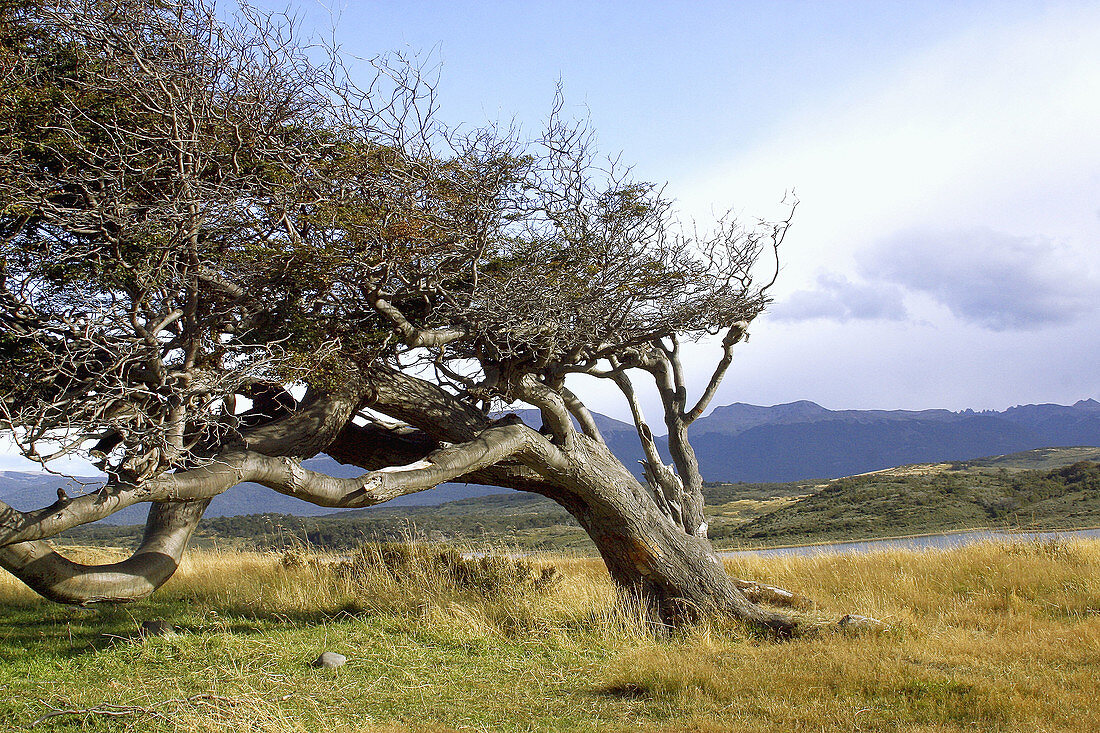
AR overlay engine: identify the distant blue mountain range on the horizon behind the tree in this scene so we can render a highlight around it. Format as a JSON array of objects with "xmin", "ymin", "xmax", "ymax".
[{"xmin": 0, "ymin": 400, "xmax": 1100, "ymax": 524}]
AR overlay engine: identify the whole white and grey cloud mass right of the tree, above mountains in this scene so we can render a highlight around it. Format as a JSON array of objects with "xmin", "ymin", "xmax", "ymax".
[{"xmin": 655, "ymin": 3, "xmax": 1100, "ymax": 408}]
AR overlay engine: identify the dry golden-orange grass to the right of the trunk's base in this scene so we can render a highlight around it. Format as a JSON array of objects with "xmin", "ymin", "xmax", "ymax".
[{"xmin": 605, "ymin": 534, "xmax": 1100, "ymax": 732}]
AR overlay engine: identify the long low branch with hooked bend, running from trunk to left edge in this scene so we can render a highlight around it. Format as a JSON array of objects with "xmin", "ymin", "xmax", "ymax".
[{"xmin": 0, "ymin": 380, "xmax": 530, "ymax": 603}]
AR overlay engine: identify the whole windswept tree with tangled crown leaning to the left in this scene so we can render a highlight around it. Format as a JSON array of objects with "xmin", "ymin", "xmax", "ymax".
[{"xmin": 0, "ymin": 0, "xmax": 818, "ymax": 633}]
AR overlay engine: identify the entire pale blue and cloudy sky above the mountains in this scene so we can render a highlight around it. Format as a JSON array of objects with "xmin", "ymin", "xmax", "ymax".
[{"xmin": 0, "ymin": 0, "xmax": 1100, "ymax": 469}]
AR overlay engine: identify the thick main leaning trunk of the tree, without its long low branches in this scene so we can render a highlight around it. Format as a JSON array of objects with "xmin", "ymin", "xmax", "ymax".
[{"xmin": 356, "ymin": 372, "xmax": 796, "ymax": 634}]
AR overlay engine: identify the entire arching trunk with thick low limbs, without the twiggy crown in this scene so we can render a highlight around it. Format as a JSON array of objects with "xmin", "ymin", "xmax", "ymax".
[{"xmin": 0, "ymin": 371, "xmax": 809, "ymax": 634}]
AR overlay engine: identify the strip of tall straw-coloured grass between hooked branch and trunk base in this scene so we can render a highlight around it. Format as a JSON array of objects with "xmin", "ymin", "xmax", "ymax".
[{"xmin": 158, "ymin": 544, "xmax": 626, "ymax": 635}]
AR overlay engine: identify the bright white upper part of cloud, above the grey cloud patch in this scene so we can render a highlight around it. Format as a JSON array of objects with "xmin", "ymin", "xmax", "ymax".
[{"xmin": 681, "ymin": 8, "xmax": 1100, "ymax": 293}]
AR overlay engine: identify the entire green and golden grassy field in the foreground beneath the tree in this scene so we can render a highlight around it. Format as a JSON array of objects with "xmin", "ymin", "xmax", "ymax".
[{"xmin": 0, "ymin": 534, "xmax": 1100, "ymax": 732}]
